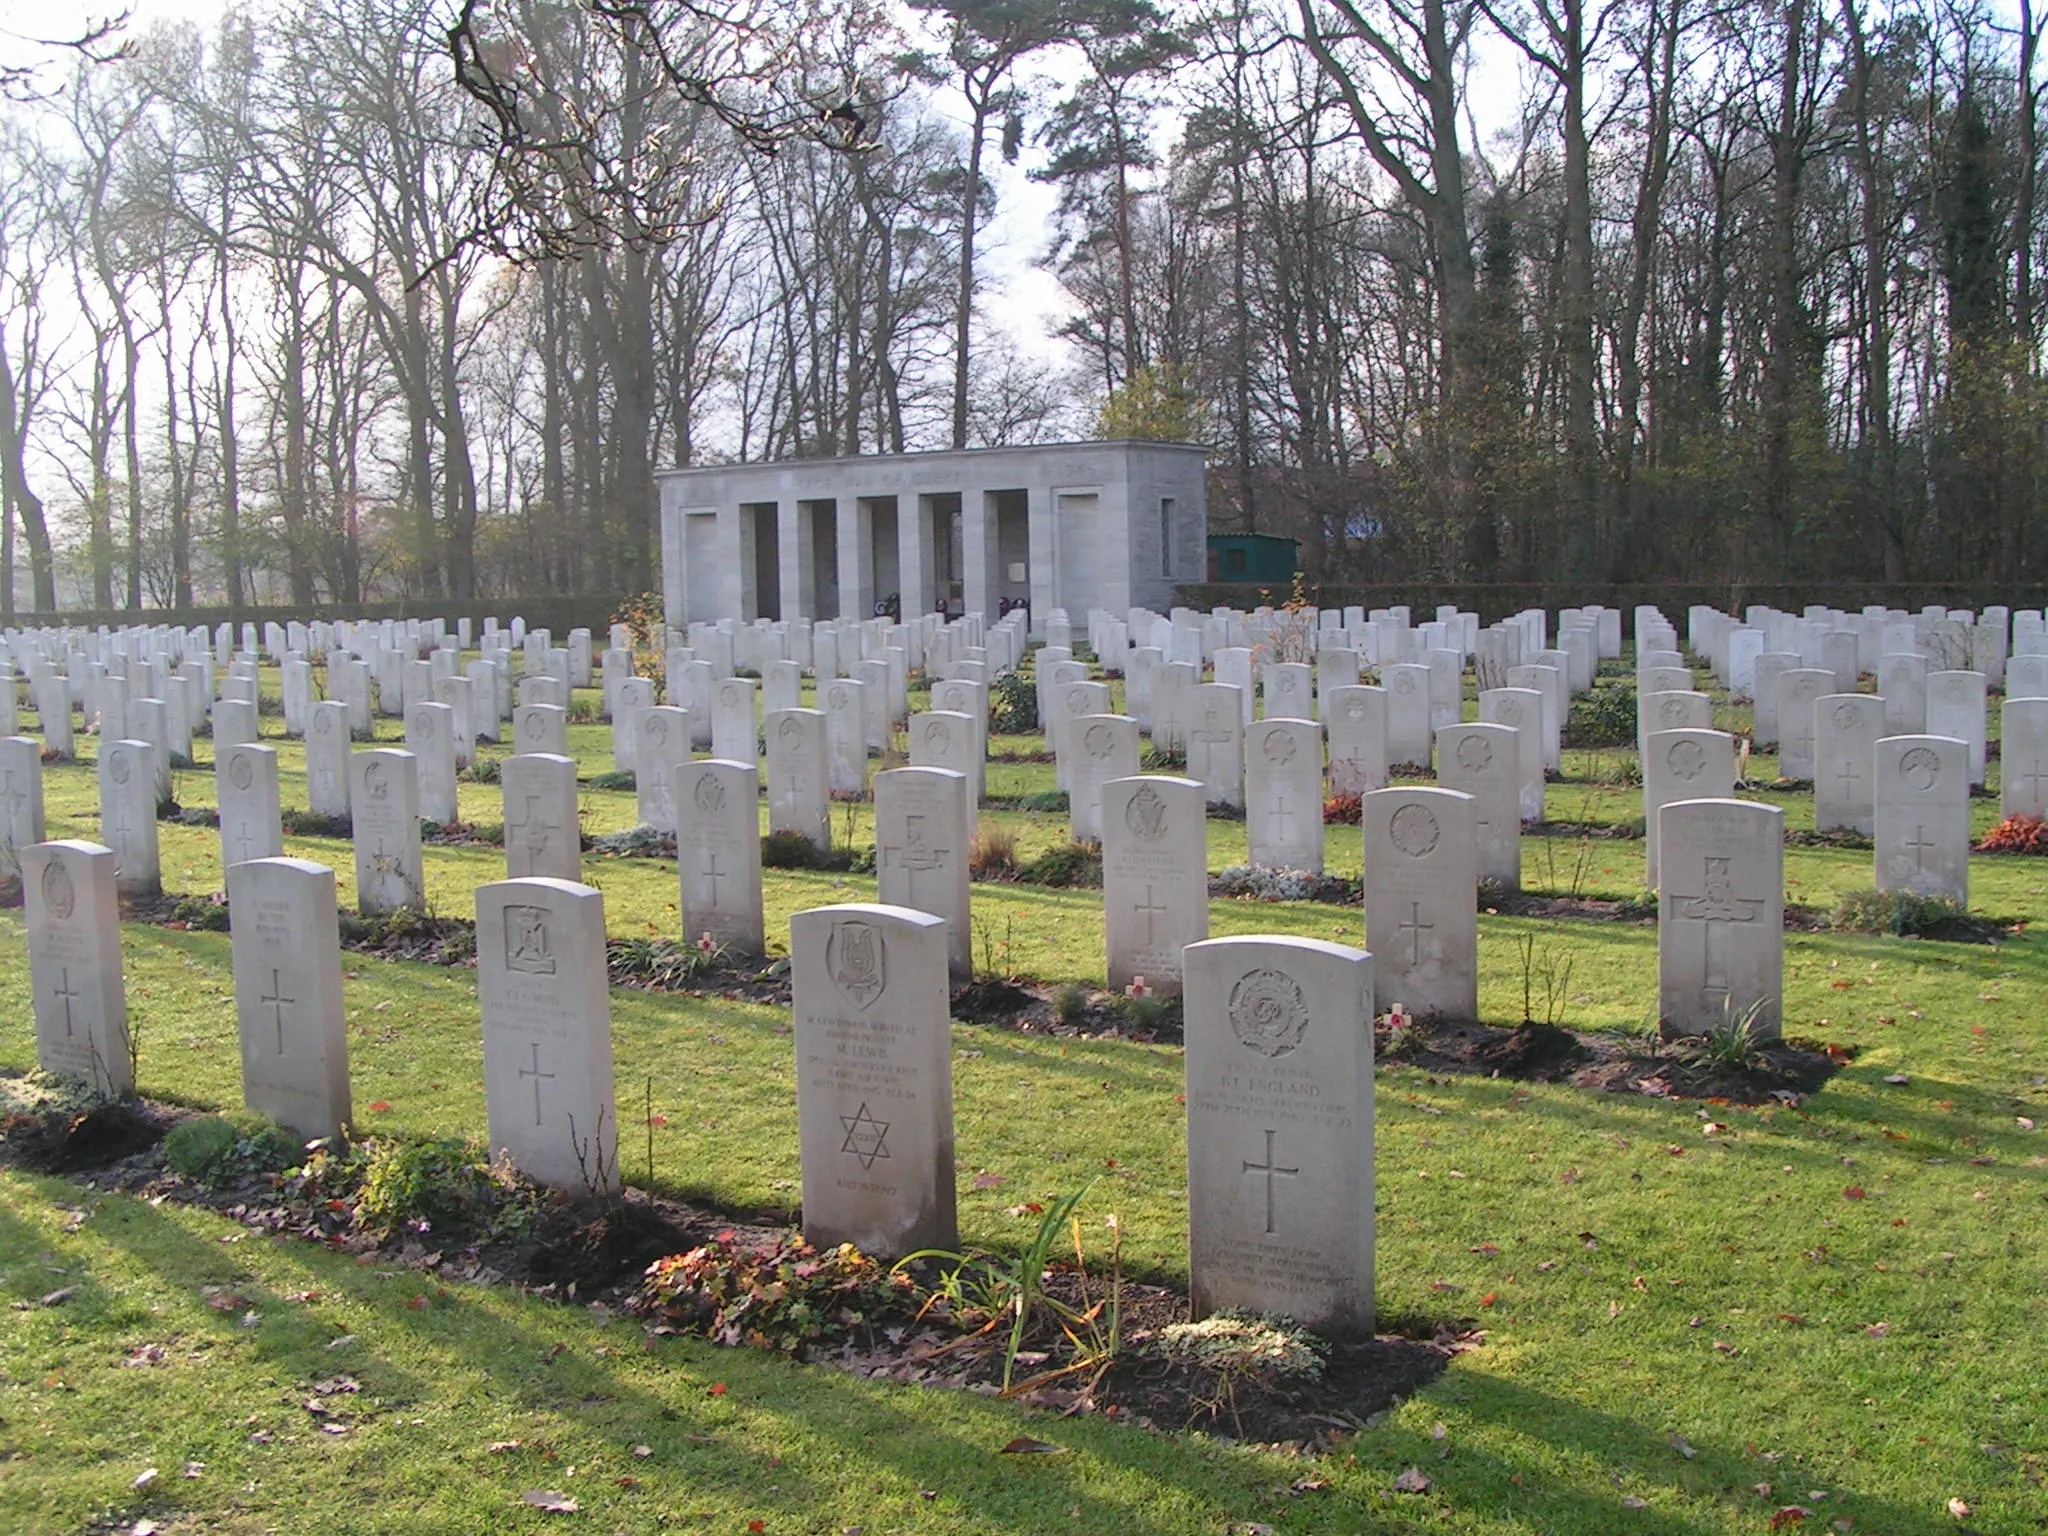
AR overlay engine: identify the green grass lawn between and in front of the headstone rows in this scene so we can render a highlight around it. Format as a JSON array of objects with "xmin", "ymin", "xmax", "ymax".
[{"xmin": 0, "ymin": 655, "xmax": 2048, "ymax": 1536}]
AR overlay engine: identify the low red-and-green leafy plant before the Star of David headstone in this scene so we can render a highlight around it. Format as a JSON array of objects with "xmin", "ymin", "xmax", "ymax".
[{"xmin": 631, "ymin": 1231, "xmax": 915, "ymax": 1360}]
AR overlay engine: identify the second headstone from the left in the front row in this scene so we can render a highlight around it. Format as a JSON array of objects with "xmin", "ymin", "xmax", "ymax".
[{"xmin": 227, "ymin": 868, "xmax": 350, "ymax": 1137}]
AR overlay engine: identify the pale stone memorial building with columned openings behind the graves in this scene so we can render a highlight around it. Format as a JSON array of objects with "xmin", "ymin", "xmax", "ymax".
[{"xmin": 657, "ymin": 440, "xmax": 1208, "ymax": 635}]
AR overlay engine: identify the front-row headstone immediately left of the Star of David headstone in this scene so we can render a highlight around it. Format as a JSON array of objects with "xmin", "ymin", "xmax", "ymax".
[{"xmin": 477, "ymin": 879, "xmax": 618, "ymax": 1194}]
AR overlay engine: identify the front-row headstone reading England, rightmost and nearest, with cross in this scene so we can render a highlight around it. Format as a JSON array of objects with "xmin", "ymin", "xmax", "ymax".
[{"xmin": 1186, "ymin": 938, "xmax": 1374, "ymax": 1339}]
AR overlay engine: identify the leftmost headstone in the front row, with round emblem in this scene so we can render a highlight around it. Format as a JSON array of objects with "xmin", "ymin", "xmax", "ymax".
[{"xmin": 20, "ymin": 840, "xmax": 135, "ymax": 1098}]
